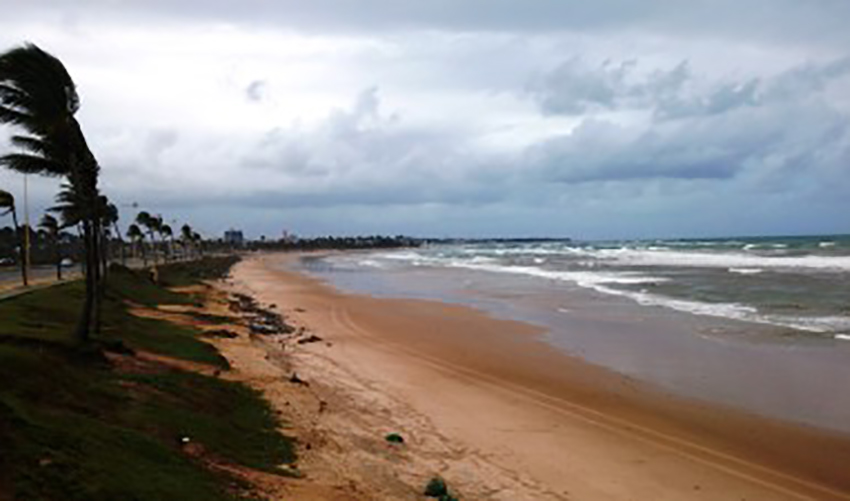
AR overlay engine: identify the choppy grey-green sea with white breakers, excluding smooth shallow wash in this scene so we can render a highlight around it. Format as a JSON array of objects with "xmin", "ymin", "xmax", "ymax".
[{"xmin": 322, "ymin": 236, "xmax": 850, "ymax": 340}]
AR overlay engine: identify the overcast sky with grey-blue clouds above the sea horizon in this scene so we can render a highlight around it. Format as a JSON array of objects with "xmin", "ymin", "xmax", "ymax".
[{"xmin": 0, "ymin": 0, "xmax": 850, "ymax": 238}]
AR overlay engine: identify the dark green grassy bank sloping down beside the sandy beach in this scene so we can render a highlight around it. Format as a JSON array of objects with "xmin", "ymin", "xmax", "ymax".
[{"xmin": 0, "ymin": 258, "xmax": 294, "ymax": 500}]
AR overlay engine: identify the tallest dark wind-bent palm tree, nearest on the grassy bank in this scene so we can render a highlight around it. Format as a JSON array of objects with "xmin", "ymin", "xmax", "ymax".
[{"xmin": 0, "ymin": 44, "xmax": 100, "ymax": 342}]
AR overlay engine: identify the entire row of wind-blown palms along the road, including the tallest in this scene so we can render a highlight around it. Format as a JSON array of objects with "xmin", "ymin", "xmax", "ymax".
[{"xmin": 0, "ymin": 44, "xmax": 202, "ymax": 343}]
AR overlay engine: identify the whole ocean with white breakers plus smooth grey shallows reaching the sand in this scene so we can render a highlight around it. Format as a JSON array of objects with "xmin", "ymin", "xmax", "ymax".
[{"xmin": 294, "ymin": 236, "xmax": 850, "ymax": 432}]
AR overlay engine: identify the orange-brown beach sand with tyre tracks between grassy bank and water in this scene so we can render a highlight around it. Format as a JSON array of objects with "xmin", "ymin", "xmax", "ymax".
[{"xmin": 218, "ymin": 254, "xmax": 850, "ymax": 500}]
